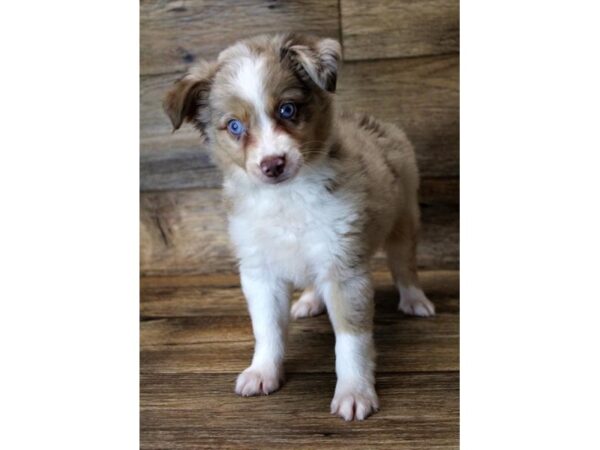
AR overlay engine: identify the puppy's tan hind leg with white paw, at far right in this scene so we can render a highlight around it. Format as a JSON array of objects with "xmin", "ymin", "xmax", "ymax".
[{"xmin": 384, "ymin": 207, "xmax": 435, "ymax": 317}]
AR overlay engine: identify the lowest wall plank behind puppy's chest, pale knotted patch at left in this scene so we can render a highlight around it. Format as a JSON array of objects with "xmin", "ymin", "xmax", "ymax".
[{"xmin": 140, "ymin": 189, "xmax": 459, "ymax": 275}]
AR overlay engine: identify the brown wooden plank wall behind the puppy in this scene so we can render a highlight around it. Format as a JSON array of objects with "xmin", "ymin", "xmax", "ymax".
[{"xmin": 140, "ymin": 0, "xmax": 459, "ymax": 275}]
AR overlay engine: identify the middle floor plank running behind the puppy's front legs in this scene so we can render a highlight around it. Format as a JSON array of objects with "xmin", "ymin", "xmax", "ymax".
[{"xmin": 140, "ymin": 287, "xmax": 459, "ymax": 374}]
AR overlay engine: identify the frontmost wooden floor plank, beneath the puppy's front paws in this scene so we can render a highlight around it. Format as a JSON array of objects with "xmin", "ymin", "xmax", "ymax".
[{"xmin": 140, "ymin": 372, "xmax": 459, "ymax": 450}]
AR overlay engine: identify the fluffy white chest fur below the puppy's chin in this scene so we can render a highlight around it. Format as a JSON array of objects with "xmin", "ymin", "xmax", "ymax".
[{"xmin": 225, "ymin": 171, "xmax": 357, "ymax": 287}]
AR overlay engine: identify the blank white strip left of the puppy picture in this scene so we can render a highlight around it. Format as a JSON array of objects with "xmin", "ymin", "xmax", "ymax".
[{"xmin": 0, "ymin": 1, "xmax": 139, "ymax": 450}]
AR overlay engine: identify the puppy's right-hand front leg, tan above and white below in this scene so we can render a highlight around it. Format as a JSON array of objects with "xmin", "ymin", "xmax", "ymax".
[{"xmin": 323, "ymin": 271, "xmax": 379, "ymax": 420}]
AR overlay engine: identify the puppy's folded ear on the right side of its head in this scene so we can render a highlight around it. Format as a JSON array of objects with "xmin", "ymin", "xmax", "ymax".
[{"xmin": 281, "ymin": 35, "xmax": 342, "ymax": 92}]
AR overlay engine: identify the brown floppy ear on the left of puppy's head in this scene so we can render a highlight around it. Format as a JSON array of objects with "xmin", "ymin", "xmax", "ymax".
[{"xmin": 163, "ymin": 61, "xmax": 217, "ymax": 134}]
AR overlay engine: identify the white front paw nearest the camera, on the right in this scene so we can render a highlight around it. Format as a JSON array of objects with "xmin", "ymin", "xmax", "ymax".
[{"xmin": 331, "ymin": 383, "xmax": 379, "ymax": 421}]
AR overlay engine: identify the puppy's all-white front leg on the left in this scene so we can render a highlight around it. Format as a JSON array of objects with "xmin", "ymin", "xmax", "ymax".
[{"xmin": 235, "ymin": 268, "xmax": 291, "ymax": 396}]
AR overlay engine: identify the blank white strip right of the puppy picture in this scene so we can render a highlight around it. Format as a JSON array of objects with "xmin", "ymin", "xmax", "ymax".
[{"xmin": 461, "ymin": 1, "xmax": 600, "ymax": 450}]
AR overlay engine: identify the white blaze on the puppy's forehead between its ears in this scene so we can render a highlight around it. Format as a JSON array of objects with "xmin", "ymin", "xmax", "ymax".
[{"xmin": 234, "ymin": 57, "xmax": 266, "ymax": 122}]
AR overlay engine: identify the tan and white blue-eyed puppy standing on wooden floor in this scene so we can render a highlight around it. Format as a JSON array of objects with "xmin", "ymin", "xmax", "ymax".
[{"xmin": 164, "ymin": 34, "xmax": 434, "ymax": 420}]
